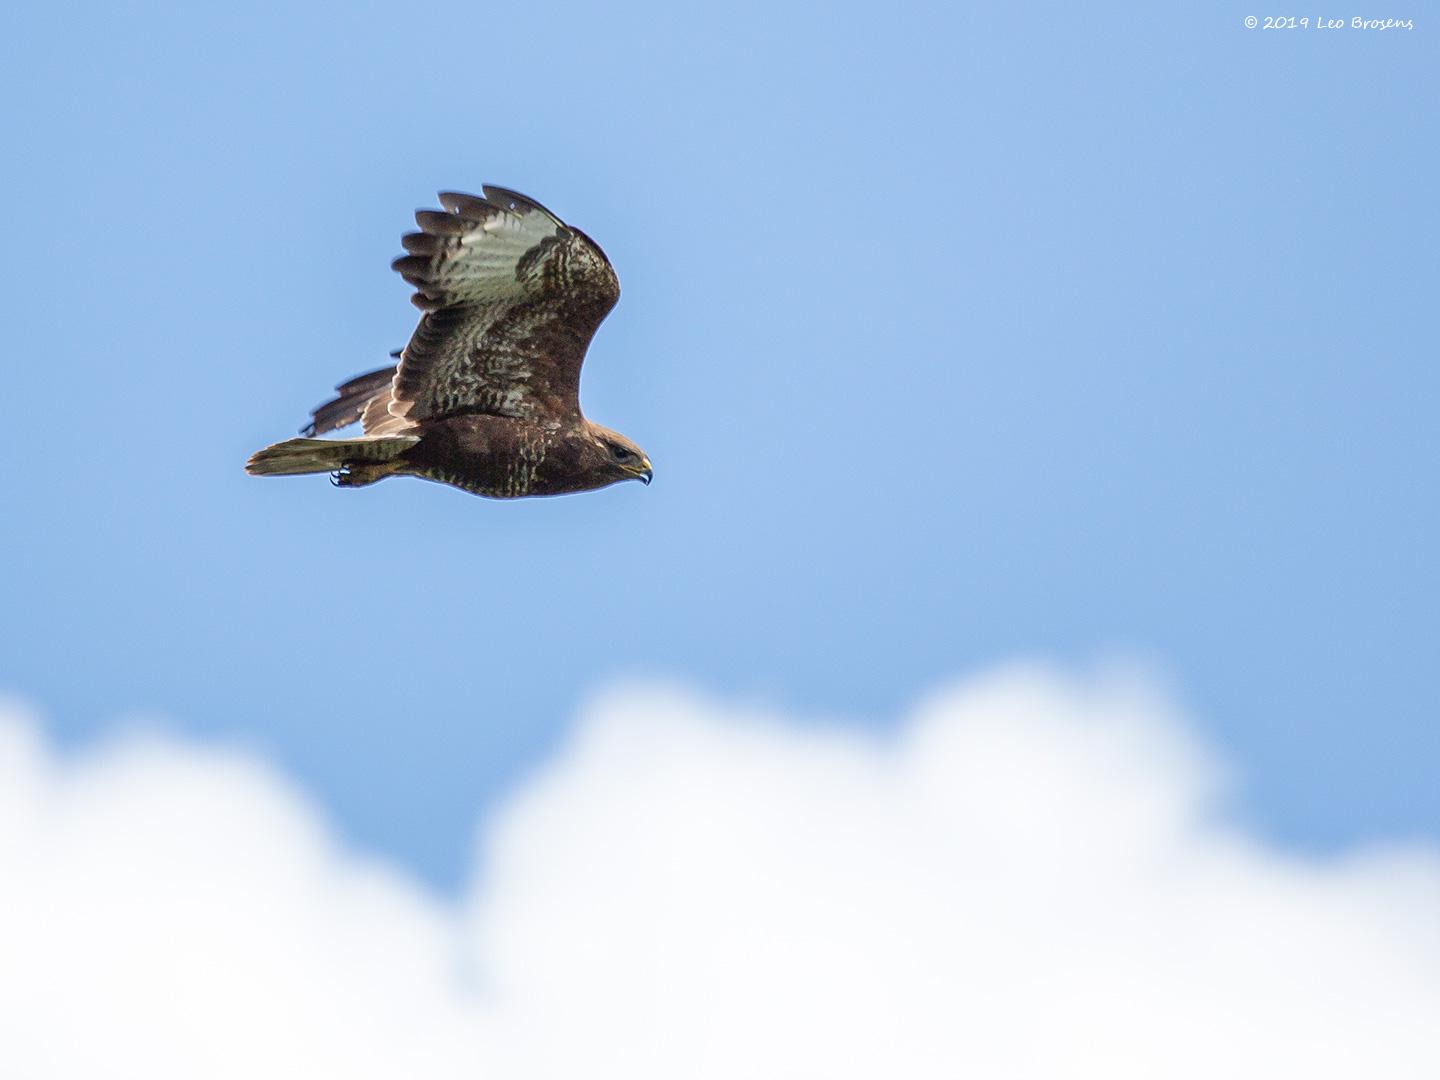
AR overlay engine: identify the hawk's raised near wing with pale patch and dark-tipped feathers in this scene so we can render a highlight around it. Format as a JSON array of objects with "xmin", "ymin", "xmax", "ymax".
[{"xmin": 383, "ymin": 186, "xmax": 621, "ymax": 432}]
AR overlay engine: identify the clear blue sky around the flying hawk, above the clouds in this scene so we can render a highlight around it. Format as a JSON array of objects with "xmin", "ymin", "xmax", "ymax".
[{"xmin": 0, "ymin": 4, "xmax": 1440, "ymax": 886}]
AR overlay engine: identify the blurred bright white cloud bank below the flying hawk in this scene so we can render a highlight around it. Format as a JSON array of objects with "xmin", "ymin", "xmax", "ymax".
[{"xmin": 0, "ymin": 670, "xmax": 1440, "ymax": 1080}]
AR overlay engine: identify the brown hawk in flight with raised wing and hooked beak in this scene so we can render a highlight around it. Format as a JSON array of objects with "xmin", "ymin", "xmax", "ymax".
[{"xmin": 245, "ymin": 186, "xmax": 651, "ymax": 498}]
